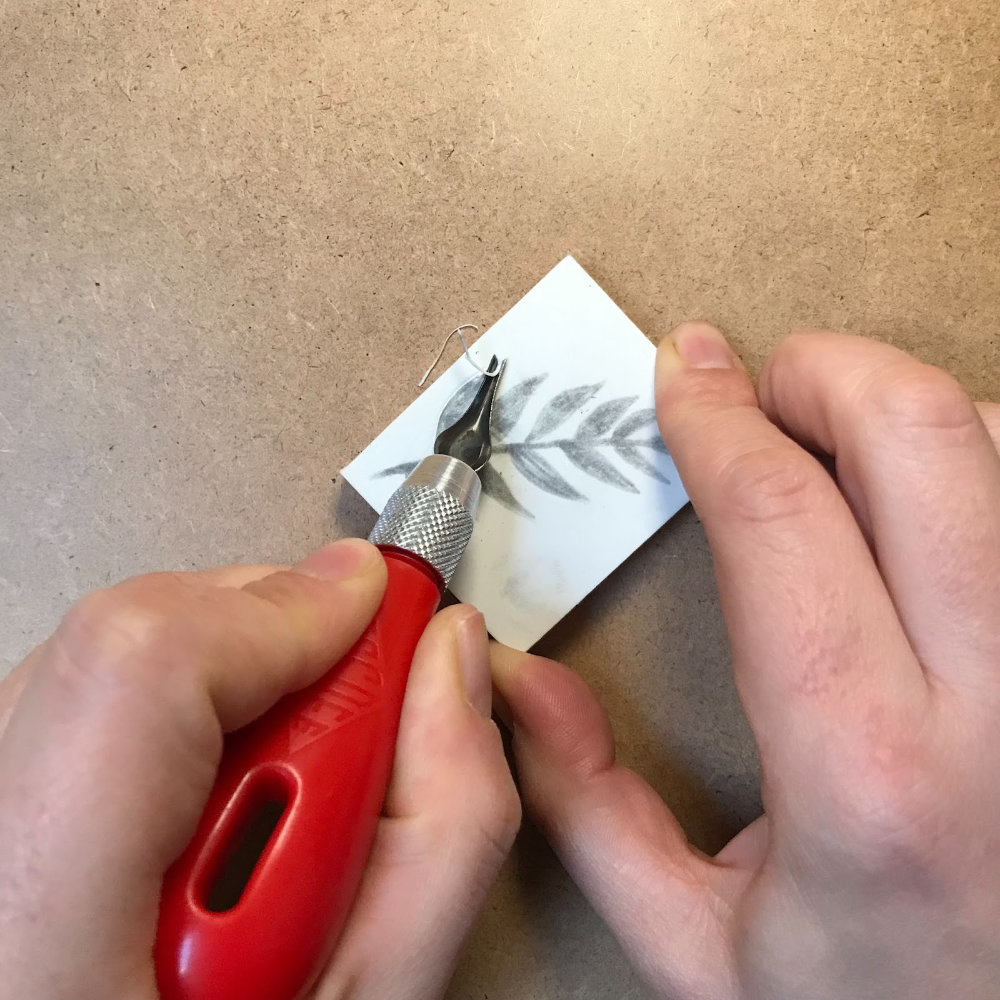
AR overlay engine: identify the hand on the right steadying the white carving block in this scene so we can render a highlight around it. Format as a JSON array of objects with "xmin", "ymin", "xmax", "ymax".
[{"xmin": 493, "ymin": 324, "xmax": 1000, "ymax": 1000}]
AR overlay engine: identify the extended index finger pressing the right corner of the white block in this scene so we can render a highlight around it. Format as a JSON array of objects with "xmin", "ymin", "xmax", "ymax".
[{"xmin": 656, "ymin": 323, "xmax": 926, "ymax": 808}]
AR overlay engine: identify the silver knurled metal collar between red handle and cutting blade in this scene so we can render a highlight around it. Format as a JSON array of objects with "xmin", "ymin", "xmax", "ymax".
[{"xmin": 368, "ymin": 455, "xmax": 482, "ymax": 586}]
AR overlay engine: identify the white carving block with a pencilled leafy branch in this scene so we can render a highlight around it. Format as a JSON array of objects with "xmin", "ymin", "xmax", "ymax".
[{"xmin": 343, "ymin": 257, "xmax": 687, "ymax": 650}]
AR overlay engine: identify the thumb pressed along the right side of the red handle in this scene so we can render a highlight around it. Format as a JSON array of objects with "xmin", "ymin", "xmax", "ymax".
[{"xmin": 315, "ymin": 605, "xmax": 521, "ymax": 1000}]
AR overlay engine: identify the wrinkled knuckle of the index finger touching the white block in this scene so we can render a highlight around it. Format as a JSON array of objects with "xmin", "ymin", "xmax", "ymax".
[{"xmin": 712, "ymin": 444, "xmax": 820, "ymax": 524}]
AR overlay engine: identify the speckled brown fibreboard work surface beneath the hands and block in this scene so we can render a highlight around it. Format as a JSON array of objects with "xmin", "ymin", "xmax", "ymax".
[{"xmin": 0, "ymin": 0, "xmax": 1000, "ymax": 1000}]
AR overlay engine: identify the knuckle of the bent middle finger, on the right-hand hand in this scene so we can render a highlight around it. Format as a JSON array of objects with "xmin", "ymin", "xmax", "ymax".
[{"xmin": 862, "ymin": 360, "xmax": 979, "ymax": 442}]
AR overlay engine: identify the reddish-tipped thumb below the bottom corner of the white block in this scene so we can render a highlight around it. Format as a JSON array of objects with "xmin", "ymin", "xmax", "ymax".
[{"xmin": 492, "ymin": 644, "xmax": 750, "ymax": 1000}]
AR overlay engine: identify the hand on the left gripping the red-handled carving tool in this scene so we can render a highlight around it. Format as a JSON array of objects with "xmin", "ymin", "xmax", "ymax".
[{"xmin": 0, "ymin": 540, "xmax": 520, "ymax": 1000}]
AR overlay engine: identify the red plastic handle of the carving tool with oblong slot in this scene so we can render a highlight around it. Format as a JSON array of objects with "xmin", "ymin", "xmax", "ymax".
[{"xmin": 155, "ymin": 549, "xmax": 441, "ymax": 1000}]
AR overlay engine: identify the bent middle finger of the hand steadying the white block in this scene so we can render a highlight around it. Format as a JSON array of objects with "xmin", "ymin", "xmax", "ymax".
[{"xmin": 760, "ymin": 331, "xmax": 1000, "ymax": 692}]
